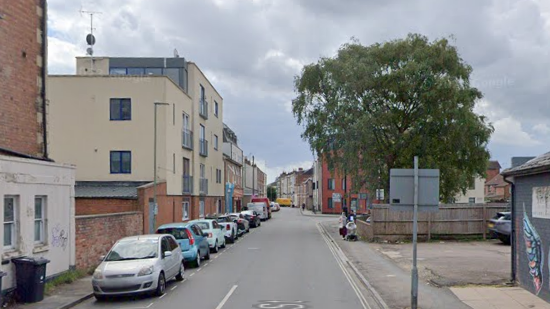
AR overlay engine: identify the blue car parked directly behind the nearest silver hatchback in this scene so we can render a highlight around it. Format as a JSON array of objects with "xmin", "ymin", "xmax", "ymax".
[{"xmin": 157, "ymin": 222, "xmax": 210, "ymax": 267}]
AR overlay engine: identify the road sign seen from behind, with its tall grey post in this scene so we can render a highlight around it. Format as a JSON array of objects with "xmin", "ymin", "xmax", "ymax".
[{"xmin": 390, "ymin": 156, "xmax": 439, "ymax": 309}]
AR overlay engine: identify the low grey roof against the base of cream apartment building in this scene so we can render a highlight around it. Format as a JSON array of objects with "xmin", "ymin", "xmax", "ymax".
[{"xmin": 74, "ymin": 181, "xmax": 149, "ymax": 199}]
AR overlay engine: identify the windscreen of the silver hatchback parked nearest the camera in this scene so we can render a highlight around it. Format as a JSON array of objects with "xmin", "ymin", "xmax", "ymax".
[{"xmin": 105, "ymin": 239, "xmax": 158, "ymax": 262}]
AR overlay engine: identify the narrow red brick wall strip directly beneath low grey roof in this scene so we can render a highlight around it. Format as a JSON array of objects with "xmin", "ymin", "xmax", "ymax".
[{"xmin": 75, "ymin": 198, "xmax": 140, "ymax": 216}]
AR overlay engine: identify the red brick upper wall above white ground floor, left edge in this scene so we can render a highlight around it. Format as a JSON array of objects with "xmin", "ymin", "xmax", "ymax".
[{"xmin": 0, "ymin": 0, "xmax": 44, "ymax": 156}]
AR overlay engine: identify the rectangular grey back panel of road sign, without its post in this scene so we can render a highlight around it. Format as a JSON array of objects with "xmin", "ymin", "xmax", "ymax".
[{"xmin": 390, "ymin": 169, "xmax": 439, "ymax": 212}]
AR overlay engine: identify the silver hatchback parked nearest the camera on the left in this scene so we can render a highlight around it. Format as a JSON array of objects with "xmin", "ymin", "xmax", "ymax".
[{"xmin": 92, "ymin": 235, "xmax": 185, "ymax": 301}]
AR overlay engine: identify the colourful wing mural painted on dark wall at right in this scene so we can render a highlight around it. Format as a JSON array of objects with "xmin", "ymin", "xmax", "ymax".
[{"xmin": 523, "ymin": 204, "xmax": 544, "ymax": 295}]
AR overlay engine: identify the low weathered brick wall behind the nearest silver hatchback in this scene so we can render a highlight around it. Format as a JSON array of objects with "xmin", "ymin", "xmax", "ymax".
[{"xmin": 75, "ymin": 212, "xmax": 143, "ymax": 269}]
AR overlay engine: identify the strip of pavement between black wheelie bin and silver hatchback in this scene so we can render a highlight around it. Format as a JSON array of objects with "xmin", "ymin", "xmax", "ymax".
[{"xmin": 10, "ymin": 277, "xmax": 93, "ymax": 309}]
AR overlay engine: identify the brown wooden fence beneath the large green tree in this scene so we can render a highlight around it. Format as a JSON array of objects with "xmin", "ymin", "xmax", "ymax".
[{"xmin": 359, "ymin": 204, "xmax": 509, "ymax": 241}]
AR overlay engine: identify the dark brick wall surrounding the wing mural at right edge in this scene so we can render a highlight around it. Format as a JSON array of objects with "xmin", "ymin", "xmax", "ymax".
[{"xmin": 512, "ymin": 173, "xmax": 550, "ymax": 301}]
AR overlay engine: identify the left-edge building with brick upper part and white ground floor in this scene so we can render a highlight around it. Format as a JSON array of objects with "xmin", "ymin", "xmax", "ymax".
[{"xmin": 0, "ymin": 0, "xmax": 75, "ymax": 294}]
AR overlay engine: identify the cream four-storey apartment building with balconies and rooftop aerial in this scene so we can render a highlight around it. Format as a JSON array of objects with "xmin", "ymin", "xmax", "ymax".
[{"xmin": 48, "ymin": 57, "xmax": 224, "ymax": 232}]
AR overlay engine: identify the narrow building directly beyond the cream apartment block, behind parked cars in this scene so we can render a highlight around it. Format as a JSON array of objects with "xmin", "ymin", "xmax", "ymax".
[{"xmin": 224, "ymin": 124, "xmax": 244, "ymax": 213}]
